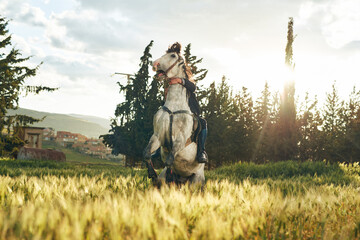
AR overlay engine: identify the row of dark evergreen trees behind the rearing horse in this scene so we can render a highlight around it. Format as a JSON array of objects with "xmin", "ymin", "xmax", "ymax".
[{"xmin": 102, "ymin": 18, "xmax": 360, "ymax": 168}]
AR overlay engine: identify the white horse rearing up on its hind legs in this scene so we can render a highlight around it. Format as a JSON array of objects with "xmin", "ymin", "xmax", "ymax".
[{"xmin": 144, "ymin": 43, "xmax": 205, "ymax": 184}]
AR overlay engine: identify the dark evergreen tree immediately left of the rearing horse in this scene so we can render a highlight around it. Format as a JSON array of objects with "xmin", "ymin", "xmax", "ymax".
[{"xmin": 101, "ymin": 41, "xmax": 160, "ymax": 166}]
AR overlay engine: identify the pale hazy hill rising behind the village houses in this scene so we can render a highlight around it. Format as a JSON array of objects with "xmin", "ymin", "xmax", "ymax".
[{"xmin": 8, "ymin": 108, "xmax": 110, "ymax": 138}]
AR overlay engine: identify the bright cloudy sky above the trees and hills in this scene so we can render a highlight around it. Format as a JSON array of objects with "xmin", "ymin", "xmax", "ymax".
[{"xmin": 0, "ymin": 0, "xmax": 360, "ymax": 119}]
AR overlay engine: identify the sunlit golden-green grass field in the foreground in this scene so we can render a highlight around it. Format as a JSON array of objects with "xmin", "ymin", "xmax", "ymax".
[{"xmin": 0, "ymin": 160, "xmax": 360, "ymax": 239}]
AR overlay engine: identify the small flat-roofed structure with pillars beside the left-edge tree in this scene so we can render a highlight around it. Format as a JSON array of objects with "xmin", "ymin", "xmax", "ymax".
[{"xmin": 17, "ymin": 127, "xmax": 44, "ymax": 148}]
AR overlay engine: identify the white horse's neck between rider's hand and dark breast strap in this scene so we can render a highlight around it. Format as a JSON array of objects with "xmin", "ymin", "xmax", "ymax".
[{"xmin": 164, "ymin": 81, "xmax": 190, "ymax": 112}]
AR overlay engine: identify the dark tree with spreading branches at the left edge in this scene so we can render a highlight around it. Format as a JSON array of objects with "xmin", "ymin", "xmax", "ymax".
[{"xmin": 0, "ymin": 17, "xmax": 56, "ymax": 157}]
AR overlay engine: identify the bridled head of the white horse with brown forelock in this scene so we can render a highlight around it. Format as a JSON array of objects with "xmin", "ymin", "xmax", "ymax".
[{"xmin": 153, "ymin": 42, "xmax": 186, "ymax": 78}]
